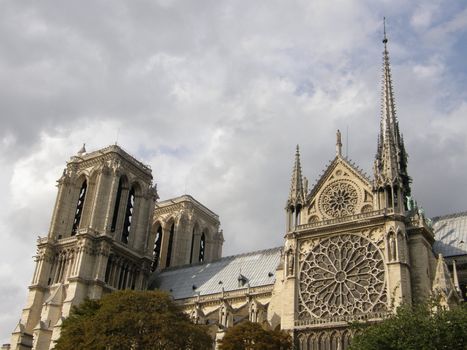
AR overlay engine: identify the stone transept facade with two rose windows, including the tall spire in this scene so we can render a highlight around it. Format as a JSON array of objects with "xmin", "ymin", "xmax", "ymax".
[{"xmin": 271, "ymin": 25, "xmax": 436, "ymax": 350}]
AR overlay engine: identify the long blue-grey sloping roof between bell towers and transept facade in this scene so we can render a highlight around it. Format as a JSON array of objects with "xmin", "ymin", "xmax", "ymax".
[{"xmin": 150, "ymin": 248, "xmax": 281, "ymax": 299}]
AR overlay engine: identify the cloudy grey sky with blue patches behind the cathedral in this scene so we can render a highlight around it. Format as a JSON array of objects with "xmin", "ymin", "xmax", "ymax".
[{"xmin": 0, "ymin": 0, "xmax": 467, "ymax": 342}]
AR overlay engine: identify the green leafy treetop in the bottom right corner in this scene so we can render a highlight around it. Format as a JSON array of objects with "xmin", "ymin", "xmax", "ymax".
[{"xmin": 350, "ymin": 303, "xmax": 467, "ymax": 350}]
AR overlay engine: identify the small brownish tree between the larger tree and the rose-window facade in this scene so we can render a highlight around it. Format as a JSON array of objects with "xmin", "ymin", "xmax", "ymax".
[{"xmin": 219, "ymin": 321, "xmax": 292, "ymax": 350}]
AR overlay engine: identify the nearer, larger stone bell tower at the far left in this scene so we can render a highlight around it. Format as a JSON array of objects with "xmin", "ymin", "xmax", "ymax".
[{"xmin": 11, "ymin": 145, "xmax": 157, "ymax": 350}]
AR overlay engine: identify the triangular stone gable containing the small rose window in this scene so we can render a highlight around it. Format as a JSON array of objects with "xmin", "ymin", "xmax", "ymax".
[{"xmin": 302, "ymin": 157, "xmax": 373, "ymax": 223}]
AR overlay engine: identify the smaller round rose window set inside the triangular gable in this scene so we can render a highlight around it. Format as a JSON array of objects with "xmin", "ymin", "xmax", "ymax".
[{"xmin": 320, "ymin": 182, "xmax": 358, "ymax": 218}]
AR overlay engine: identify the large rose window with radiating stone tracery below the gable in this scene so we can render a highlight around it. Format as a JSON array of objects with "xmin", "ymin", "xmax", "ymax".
[{"xmin": 299, "ymin": 234, "xmax": 386, "ymax": 318}]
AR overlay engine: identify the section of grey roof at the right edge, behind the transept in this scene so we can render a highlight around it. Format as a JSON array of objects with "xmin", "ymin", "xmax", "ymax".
[{"xmin": 433, "ymin": 212, "xmax": 467, "ymax": 257}]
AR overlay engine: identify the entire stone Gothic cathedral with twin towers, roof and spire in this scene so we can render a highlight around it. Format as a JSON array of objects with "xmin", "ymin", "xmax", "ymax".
[{"xmin": 4, "ymin": 31, "xmax": 467, "ymax": 350}]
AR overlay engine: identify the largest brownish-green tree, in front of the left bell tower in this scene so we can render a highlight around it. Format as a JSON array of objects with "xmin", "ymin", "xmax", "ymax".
[{"xmin": 55, "ymin": 290, "xmax": 212, "ymax": 350}]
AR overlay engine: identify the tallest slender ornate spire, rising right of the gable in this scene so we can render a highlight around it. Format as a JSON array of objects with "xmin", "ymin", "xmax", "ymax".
[{"xmin": 374, "ymin": 20, "xmax": 410, "ymax": 199}]
